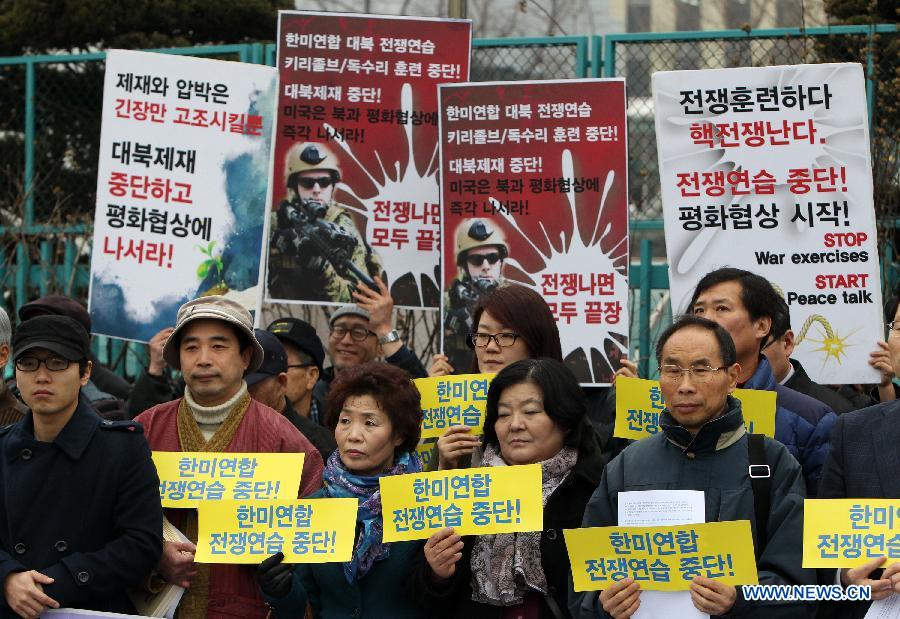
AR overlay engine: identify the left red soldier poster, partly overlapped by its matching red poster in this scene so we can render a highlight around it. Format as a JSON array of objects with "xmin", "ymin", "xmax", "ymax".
[{"xmin": 267, "ymin": 11, "xmax": 472, "ymax": 308}]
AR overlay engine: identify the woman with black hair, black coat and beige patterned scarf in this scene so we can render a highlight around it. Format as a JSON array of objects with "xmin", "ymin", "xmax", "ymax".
[{"xmin": 414, "ymin": 359, "xmax": 603, "ymax": 619}]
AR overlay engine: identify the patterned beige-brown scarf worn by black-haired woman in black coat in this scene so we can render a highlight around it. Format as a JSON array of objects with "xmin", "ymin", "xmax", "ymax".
[{"xmin": 472, "ymin": 445, "xmax": 578, "ymax": 606}]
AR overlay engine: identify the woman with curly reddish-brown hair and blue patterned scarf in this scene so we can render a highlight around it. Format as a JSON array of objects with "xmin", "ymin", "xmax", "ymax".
[{"xmin": 258, "ymin": 362, "xmax": 423, "ymax": 618}]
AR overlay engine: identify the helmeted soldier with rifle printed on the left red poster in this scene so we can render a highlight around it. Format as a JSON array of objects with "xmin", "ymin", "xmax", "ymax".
[{"xmin": 268, "ymin": 142, "xmax": 382, "ymax": 303}]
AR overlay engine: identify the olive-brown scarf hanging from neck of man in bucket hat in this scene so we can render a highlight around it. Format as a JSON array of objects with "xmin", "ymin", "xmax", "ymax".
[{"xmin": 175, "ymin": 391, "xmax": 250, "ymax": 619}]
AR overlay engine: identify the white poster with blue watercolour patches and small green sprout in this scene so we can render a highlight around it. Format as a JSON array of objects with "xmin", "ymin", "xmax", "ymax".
[{"xmin": 89, "ymin": 50, "xmax": 277, "ymax": 342}]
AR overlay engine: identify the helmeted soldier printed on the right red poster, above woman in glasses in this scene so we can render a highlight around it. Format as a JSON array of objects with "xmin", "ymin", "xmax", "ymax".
[{"xmin": 444, "ymin": 219, "xmax": 509, "ymax": 368}]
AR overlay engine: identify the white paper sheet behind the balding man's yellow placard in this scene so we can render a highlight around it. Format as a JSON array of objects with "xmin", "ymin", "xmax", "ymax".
[{"xmin": 619, "ymin": 490, "xmax": 709, "ymax": 619}]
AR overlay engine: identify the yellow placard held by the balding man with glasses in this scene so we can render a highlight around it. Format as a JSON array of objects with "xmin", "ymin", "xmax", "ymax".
[{"xmin": 563, "ymin": 520, "xmax": 759, "ymax": 591}]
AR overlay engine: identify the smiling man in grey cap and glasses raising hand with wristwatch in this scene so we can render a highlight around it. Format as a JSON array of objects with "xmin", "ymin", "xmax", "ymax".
[{"xmin": 313, "ymin": 298, "xmax": 428, "ymax": 423}]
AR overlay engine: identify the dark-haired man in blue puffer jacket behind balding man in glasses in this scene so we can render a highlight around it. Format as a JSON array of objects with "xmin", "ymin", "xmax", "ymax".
[{"xmin": 689, "ymin": 267, "xmax": 837, "ymax": 496}]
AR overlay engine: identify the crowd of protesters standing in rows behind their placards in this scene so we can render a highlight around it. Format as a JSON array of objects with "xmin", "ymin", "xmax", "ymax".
[{"xmin": 0, "ymin": 268, "xmax": 900, "ymax": 619}]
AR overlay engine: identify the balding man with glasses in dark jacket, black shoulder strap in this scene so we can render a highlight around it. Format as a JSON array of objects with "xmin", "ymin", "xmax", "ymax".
[{"xmin": 570, "ymin": 315, "xmax": 816, "ymax": 619}]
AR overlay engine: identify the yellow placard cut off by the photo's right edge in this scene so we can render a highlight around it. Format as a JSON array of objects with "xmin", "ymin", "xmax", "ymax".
[{"xmin": 803, "ymin": 499, "xmax": 900, "ymax": 567}]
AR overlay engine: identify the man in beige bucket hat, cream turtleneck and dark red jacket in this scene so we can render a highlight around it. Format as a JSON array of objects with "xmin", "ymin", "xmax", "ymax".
[{"xmin": 136, "ymin": 296, "xmax": 323, "ymax": 619}]
